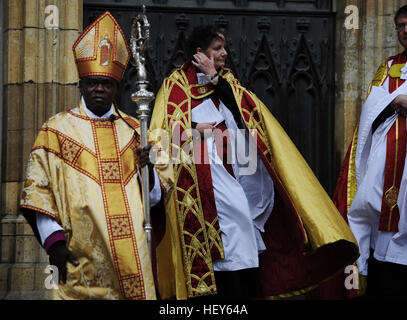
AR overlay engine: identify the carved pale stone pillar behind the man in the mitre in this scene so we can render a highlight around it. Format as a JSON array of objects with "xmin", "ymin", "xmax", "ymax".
[{"xmin": 0, "ymin": 0, "xmax": 83, "ymax": 299}]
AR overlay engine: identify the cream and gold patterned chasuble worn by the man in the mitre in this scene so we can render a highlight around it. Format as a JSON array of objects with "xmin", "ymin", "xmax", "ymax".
[{"xmin": 20, "ymin": 105, "xmax": 172, "ymax": 299}]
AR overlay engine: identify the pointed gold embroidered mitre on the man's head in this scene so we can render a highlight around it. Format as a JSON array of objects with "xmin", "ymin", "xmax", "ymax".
[{"xmin": 72, "ymin": 11, "xmax": 130, "ymax": 82}]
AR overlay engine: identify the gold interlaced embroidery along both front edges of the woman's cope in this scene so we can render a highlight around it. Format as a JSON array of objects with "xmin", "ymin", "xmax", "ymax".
[{"xmin": 164, "ymin": 69, "xmax": 272, "ymax": 297}]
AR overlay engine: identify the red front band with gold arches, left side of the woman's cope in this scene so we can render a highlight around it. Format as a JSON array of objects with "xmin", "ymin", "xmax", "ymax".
[{"xmin": 167, "ymin": 64, "xmax": 224, "ymax": 297}]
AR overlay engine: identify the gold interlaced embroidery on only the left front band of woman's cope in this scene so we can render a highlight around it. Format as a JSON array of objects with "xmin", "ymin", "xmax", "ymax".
[{"xmin": 164, "ymin": 74, "xmax": 224, "ymax": 297}]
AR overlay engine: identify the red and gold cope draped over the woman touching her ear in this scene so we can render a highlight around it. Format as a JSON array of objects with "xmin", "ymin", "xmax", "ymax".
[{"xmin": 150, "ymin": 63, "xmax": 358, "ymax": 299}]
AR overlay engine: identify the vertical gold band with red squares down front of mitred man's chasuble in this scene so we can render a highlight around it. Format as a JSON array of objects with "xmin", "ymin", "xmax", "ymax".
[{"xmin": 91, "ymin": 121, "xmax": 146, "ymax": 299}]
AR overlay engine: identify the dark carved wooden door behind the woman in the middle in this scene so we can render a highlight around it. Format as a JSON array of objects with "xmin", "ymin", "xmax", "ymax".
[{"xmin": 84, "ymin": 0, "xmax": 336, "ymax": 193}]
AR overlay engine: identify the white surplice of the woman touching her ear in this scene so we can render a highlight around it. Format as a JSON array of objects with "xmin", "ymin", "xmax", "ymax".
[{"xmin": 191, "ymin": 74, "xmax": 274, "ymax": 271}]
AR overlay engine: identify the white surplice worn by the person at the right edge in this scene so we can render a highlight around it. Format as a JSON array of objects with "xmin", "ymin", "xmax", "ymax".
[{"xmin": 348, "ymin": 61, "xmax": 407, "ymax": 275}]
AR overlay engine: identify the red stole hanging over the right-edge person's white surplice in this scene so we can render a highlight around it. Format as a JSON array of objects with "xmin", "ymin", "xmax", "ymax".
[{"xmin": 379, "ymin": 52, "xmax": 407, "ymax": 232}]
